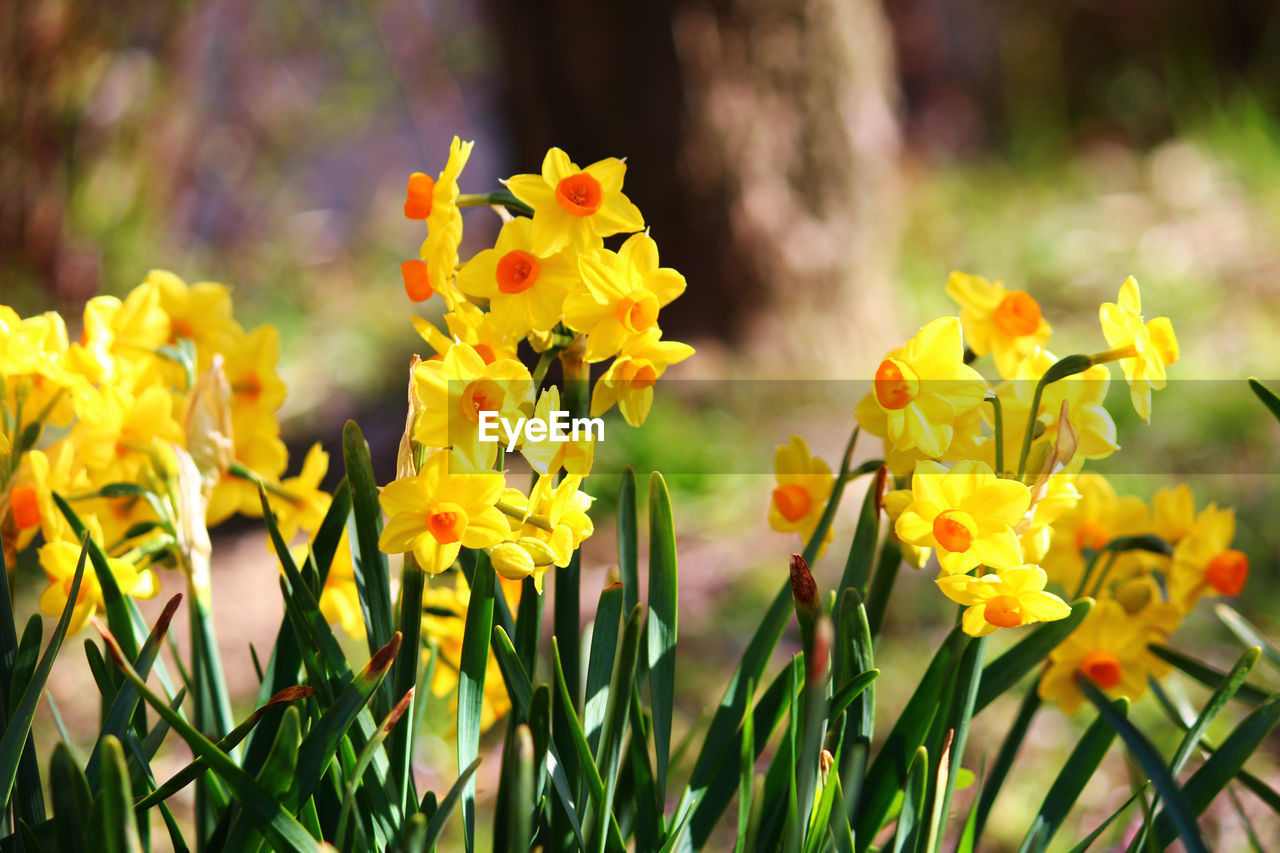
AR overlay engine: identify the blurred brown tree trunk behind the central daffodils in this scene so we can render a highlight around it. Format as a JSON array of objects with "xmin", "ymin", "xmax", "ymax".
[{"xmin": 490, "ymin": 0, "xmax": 899, "ymax": 377}]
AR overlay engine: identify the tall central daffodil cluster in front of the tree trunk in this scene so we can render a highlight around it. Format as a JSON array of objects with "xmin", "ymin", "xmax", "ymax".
[{"xmin": 379, "ymin": 137, "xmax": 692, "ymax": 722}]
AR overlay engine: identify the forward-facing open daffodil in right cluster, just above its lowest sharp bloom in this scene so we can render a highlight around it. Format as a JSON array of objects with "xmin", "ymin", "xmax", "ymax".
[{"xmin": 893, "ymin": 462, "xmax": 1030, "ymax": 574}]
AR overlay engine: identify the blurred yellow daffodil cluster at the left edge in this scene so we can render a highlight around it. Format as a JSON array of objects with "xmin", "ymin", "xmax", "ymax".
[{"xmin": 0, "ymin": 270, "xmax": 350, "ymax": 630}]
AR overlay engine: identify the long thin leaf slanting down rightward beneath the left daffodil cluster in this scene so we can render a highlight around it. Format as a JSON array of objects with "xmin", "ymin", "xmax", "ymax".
[{"xmin": 100, "ymin": 628, "xmax": 316, "ymax": 853}]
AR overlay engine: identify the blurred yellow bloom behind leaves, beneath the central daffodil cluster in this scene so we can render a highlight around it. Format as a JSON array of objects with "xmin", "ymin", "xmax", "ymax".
[{"xmin": 422, "ymin": 571, "xmax": 515, "ymax": 731}]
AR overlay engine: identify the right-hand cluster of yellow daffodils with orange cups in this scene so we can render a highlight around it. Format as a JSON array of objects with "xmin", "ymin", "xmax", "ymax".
[{"xmin": 769, "ymin": 273, "xmax": 1248, "ymax": 712}]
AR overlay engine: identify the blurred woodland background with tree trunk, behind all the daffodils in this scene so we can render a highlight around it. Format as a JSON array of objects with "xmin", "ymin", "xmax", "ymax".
[{"xmin": 0, "ymin": 0, "xmax": 1280, "ymax": 849}]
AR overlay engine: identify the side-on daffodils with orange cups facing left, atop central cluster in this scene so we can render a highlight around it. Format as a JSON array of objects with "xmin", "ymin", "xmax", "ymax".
[{"xmin": 401, "ymin": 137, "xmax": 475, "ymax": 307}]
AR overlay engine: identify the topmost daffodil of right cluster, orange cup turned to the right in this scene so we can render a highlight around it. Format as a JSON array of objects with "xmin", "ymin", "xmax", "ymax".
[{"xmin": 947, "ymin": 273, "xmax": 1051, "ymax": 378}]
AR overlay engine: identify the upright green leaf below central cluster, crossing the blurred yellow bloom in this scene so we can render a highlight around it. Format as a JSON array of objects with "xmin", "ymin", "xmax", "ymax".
[{"xmin": 457, "ymin": 552, "xmax": 494, "ymax": 853}]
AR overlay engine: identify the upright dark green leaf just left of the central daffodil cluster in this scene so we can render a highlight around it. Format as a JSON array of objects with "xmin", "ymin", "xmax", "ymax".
[{"xmin": 342, "ymin": 420, "xmax": 393, "ymax": 654}]
